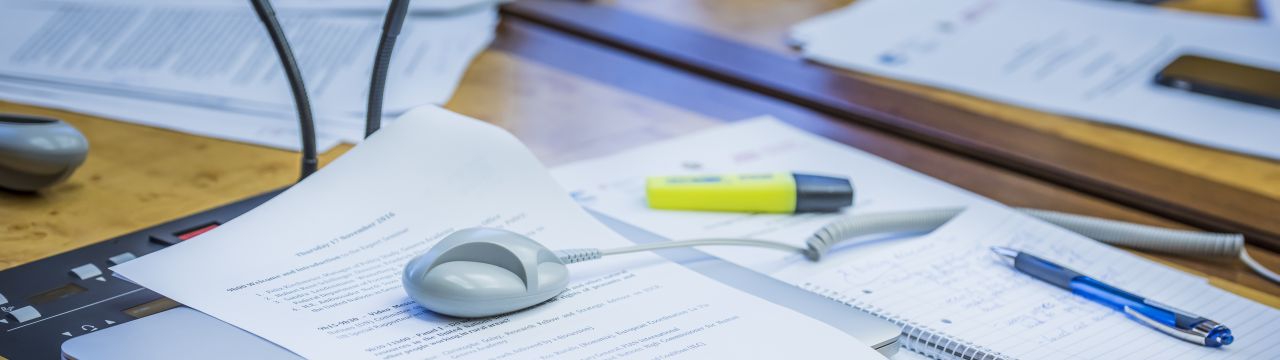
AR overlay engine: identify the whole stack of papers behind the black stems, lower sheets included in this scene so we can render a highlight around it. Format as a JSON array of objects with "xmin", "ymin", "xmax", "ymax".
[{"xmin": 0, "ymin": 0, "xmax": 498, "ymax": 150}]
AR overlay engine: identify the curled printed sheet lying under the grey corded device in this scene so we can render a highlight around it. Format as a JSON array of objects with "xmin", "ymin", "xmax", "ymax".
[{"xmin": 111, "ymin": 106, "xmax": 881, "ymax": 359}]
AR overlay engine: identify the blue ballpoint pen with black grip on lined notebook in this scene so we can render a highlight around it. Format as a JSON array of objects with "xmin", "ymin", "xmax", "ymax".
[{"xmin": 991, "ymin": 246, "xmax": 1235, "ymax": 347}]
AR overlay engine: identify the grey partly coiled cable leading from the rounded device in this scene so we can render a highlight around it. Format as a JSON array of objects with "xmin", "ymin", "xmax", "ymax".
[{"xmin": 557, "ymin": 208, "xmax": 1280, "ymax": 283}]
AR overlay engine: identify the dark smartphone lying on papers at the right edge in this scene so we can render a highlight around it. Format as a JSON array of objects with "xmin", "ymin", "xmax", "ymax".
[{"xmin": 1156, "ymin": 55, "xmax": 1280, "ymax": 109}]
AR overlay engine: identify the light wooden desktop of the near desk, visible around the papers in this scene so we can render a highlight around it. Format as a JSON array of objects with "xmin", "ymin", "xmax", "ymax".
[{"xmin": 0, "ymin": 14, "xmax": 1280, "ymax": 313}]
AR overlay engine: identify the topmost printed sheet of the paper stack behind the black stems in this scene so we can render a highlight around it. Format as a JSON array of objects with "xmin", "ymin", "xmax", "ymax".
[{"xmin": 0, "ymin": 3, "xmax": 497, "ymax": 113}]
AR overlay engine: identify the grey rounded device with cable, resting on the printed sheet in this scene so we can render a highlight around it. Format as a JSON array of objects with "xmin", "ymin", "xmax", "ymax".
[{"xmin": 403, "ymin": 228, "xmax": 568, "ymax": 318}]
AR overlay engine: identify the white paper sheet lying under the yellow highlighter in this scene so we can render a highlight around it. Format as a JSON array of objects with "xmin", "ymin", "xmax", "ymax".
[{"xmin": 552, "ymin": 117, "xmax": 988, "ymax": 282}]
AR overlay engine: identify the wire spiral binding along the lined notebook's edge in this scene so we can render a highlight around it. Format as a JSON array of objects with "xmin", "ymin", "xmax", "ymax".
[{"xmin": 801, "ymin": 283, "xmax": 1010, "ymax": 360}]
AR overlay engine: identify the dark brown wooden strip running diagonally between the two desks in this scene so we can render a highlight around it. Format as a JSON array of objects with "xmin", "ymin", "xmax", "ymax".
[{"xmin": 504, "ymin": 0, "xmax": 1280, "ymax": 250}]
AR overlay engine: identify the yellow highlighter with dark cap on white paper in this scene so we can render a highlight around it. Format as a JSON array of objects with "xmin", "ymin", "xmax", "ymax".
[{"xmin": 645, "ymin": 172, "xmax": 854, "ymax": 214}]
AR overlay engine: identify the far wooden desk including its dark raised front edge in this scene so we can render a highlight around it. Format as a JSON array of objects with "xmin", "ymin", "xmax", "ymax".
[{"xmin": 507, "ymin": 0, "xmax": 1280, "ymax": 250}]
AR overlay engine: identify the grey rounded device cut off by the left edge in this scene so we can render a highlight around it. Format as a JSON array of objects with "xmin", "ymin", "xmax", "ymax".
[{"xmin": 0, "ymin": 114, "xmax": 88, "ymax": 191}]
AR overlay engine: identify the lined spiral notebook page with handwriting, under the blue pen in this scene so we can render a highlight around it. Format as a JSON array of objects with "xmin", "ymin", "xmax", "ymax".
[{"xmin": 805, "ymin": 205, "xmax": 1280, "ymax": 359}]
